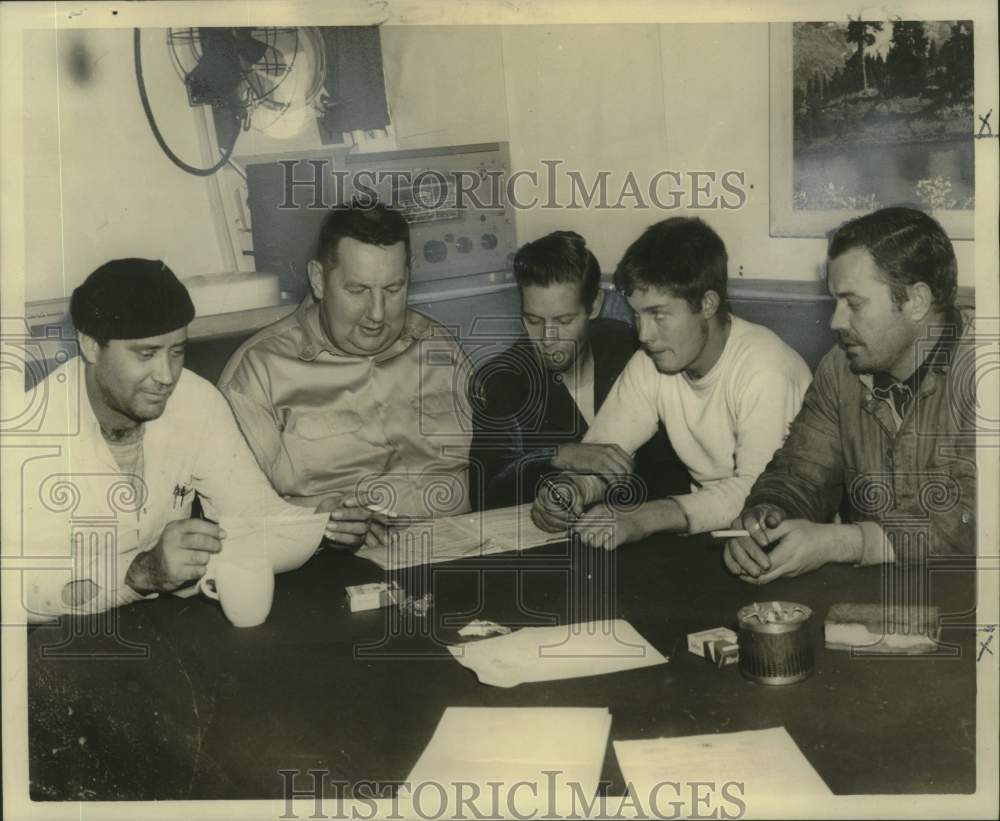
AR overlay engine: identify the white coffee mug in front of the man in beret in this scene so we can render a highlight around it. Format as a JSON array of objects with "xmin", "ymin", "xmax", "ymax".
[{"xmin": 198, "ymin": 554, "xmax": 274, "ymax": 627}]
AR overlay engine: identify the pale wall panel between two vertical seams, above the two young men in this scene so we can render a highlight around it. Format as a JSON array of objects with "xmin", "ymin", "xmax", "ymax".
[{"xmin": 503, "ymin": 25, "xmax": 668, "ymax": 270}]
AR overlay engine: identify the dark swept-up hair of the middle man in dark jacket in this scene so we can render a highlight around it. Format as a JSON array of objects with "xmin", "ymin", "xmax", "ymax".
[{"xmin": 514, "ymin": 231, "xmax": 601, "ymax": 311}]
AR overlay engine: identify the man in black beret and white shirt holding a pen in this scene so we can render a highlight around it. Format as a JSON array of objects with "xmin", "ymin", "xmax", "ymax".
[{"xmin": 22, "ymin": 259, "xmax": 336, "ymax": 621}]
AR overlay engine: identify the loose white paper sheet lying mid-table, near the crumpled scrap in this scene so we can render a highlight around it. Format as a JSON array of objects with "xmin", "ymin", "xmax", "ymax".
[{"xmin": 448, "ymin": 619, "xmax": 667, "ymax": 687}]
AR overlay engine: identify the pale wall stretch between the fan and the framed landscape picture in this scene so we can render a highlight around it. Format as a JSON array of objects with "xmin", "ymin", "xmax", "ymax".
[{"xmin": 382, "ymin": 23, "xmax": 974, "ymax": 285}]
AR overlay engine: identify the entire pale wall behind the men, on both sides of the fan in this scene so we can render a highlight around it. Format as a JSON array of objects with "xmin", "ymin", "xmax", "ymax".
[{"xmin": 24, "ymin": 23, "xmax": 974, "ymax": 300}]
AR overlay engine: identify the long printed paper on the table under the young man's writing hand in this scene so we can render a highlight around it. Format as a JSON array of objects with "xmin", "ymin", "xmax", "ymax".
[{"xmin": 357, "ymin": 504, "xmax": 567, "ymax": 570}]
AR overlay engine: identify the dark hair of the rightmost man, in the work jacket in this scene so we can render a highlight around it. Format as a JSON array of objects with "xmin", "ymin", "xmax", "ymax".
[{"xmin": 827, "ymin": 207, "xmax": 958, "ymax": 311}]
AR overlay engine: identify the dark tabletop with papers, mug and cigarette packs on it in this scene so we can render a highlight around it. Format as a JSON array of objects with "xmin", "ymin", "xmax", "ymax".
[{"xmin": 28, "ymin": 537, "xmax": 976, "ymax": 800}]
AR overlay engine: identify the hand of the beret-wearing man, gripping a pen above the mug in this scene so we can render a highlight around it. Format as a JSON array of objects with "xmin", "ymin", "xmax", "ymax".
[{"xmin": 125, "ymin": 519, "xmax": 226, "ymax": 595}]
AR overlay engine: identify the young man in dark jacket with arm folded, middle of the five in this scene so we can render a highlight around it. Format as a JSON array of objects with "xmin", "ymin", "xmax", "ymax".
[{"xmin": 469, "ymin": 231, "xmax": 690, "ymax": 509}]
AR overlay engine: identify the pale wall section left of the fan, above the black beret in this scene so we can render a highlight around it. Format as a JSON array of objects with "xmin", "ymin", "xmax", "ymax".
[{"xmin": 24, "ymin": 29, "xmax": 225, "ymax": 301}]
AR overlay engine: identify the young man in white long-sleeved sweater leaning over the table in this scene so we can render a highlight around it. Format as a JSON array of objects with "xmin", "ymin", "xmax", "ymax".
[{"xmin": 533, "ymin": 217, "xmax": 811, "ymax": 549}]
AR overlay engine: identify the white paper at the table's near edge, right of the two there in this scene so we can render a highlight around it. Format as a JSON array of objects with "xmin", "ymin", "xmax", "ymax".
[{"xmin": 614, "ymin": 727, "xmax": 832, "ymax": 818}]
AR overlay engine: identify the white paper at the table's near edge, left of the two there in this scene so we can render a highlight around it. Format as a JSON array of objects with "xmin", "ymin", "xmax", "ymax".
[{"xmin": 400, "ymin": 707, "xmax": 611, "ymax": 818}]
